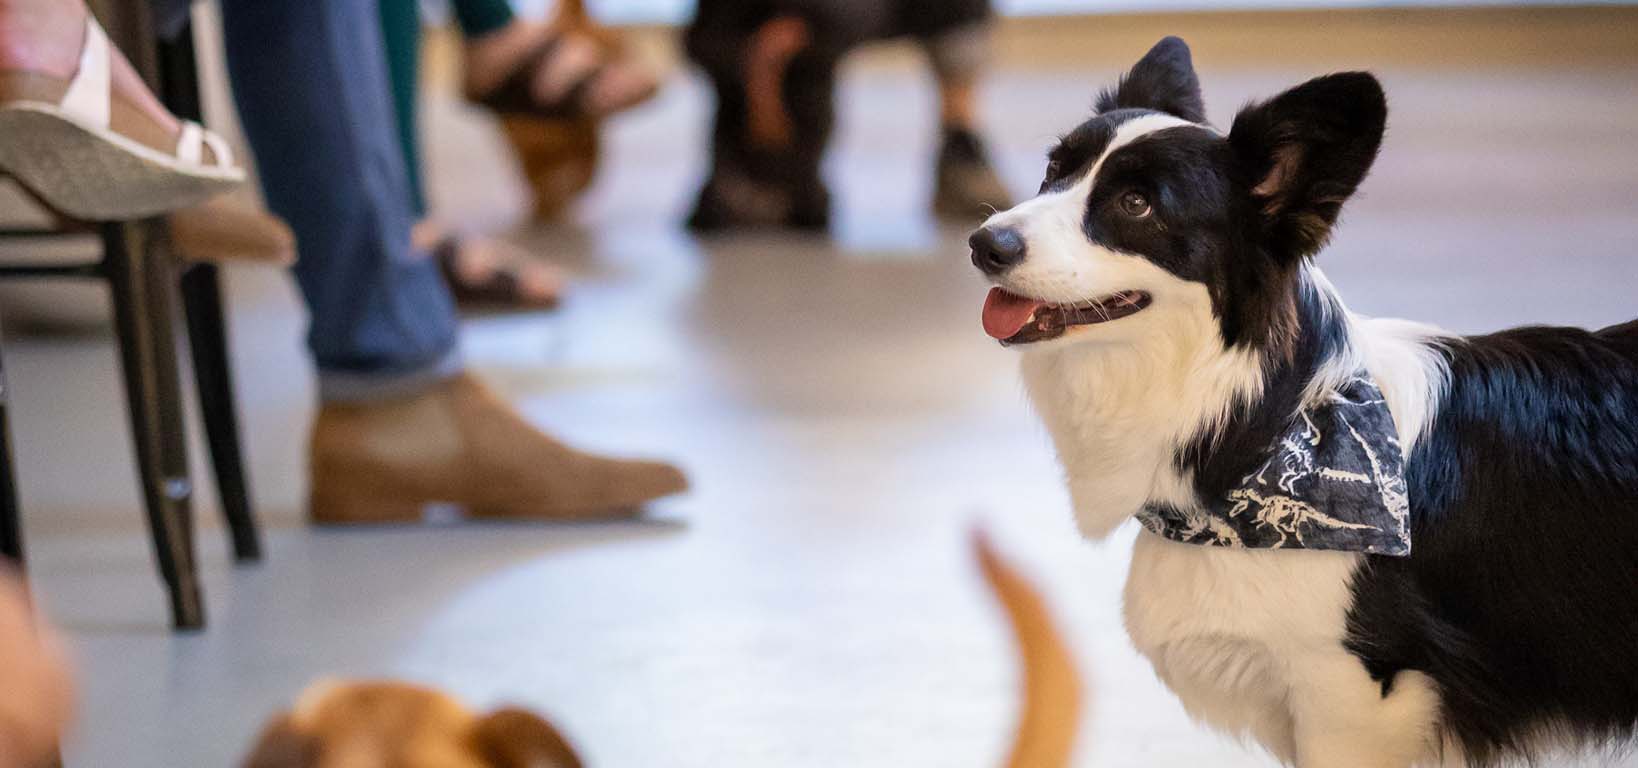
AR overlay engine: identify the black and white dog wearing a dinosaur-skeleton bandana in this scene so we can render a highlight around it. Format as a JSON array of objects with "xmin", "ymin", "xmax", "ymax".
[{"xmin": 971, "ymin": 38, "xmax": 1638, "ymax": 768}]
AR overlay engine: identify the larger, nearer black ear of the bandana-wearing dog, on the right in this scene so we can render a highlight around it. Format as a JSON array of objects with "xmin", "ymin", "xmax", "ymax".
[{"xmin": 1229, "ymin": 72, "xmax": 1387, "ymax": 257}]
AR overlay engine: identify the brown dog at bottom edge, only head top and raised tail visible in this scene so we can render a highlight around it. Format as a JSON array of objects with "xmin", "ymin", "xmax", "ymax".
[{"xmin": 244, "ymin": 534, "xmax": 1081, "ymax": 768}]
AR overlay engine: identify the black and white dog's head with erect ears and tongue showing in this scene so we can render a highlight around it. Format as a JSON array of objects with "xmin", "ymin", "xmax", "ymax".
[{"xmin": 970, "ymin": 38, "xmax": 1387, "ymax": 349}]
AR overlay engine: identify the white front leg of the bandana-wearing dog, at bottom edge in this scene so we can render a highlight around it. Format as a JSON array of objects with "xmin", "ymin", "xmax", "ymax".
[{"xmin": 1291, "ymin": 650, "xmax": 1438, "ymax": 768}]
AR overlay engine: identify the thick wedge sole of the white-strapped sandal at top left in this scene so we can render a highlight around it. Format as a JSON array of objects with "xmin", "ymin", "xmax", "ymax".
[{"xmin": 0, "ymin": 102, "xmax": 244, "ymax": 221}]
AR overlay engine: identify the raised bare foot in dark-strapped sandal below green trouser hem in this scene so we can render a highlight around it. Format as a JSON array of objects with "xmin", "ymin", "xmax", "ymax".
[{"xmin": 465, "ymin": 20, "xmax": 655, "ymax": 116}]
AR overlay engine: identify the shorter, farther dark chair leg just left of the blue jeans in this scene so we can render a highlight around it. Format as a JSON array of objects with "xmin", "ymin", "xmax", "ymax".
[{"xmin": 182, "ymin": 264, "xmax": 262, "ymax": 563}]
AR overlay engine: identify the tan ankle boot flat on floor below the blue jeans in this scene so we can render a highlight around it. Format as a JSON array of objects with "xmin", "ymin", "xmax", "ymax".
[{"xmin": 308, "ymin": 373, "xmax": 688, "ymax": 524}]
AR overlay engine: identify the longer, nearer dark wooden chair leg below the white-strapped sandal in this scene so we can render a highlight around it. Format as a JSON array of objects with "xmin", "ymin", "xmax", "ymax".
[{"xmin": 103, "ymin": 221, "xmax": 205, "ymax": 629}]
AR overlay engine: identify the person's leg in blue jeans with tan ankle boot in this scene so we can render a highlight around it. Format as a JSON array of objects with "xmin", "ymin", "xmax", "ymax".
[{"xmin": 223, "ymin": 0, "xmax": 686, "ymax": 524}]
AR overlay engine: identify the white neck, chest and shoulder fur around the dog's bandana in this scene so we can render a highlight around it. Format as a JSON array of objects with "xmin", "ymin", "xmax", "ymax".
[{"xmin": 1024, "ymin": 286, "xmax": 1445, "ymax": 765}]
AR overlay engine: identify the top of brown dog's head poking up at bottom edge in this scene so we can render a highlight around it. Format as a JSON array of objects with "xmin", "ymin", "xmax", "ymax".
[{"xmin": 244, "ymin": 681, "xmax": 581, "ymax": 768}]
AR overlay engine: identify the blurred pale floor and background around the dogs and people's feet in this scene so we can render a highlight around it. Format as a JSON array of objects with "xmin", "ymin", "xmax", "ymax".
[{"xmin": 0, "ymin": 0, "xmax": 1638, "ymax": 766}]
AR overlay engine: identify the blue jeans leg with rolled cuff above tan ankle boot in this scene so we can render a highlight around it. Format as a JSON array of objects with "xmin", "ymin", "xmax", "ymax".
[{"xmin": 221, "ymin": 0, "xmax": 460, "ymax": 398}]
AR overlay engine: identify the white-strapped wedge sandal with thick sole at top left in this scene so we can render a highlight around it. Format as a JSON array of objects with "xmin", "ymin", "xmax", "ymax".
[{"xmin": 0, "ymin": 16, "xmax": 244, "ymax": 221}]
